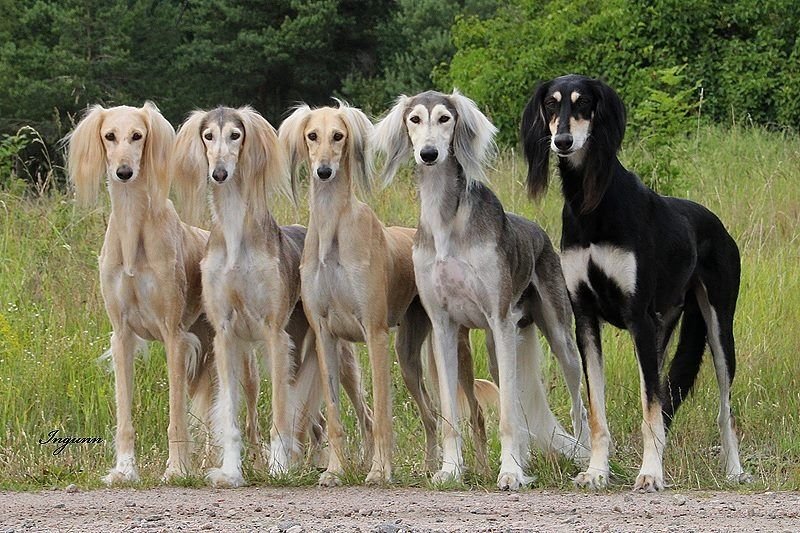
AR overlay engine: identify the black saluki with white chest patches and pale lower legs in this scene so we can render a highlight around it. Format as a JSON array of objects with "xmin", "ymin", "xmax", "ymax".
[{"xmin": 521, "ymin": 75, "xmax": 748, "ymax": 492}]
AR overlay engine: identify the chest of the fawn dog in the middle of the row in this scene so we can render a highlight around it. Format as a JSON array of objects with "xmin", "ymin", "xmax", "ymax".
[{"xmin": 302, "ymin": 256, "xmax": 368, "ymax": 342}]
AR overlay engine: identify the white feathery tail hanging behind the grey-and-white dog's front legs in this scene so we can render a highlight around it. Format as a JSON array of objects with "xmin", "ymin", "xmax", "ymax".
[{"xmin": 517, "ymin": 325, "xmax": 587, "ymax": 460}]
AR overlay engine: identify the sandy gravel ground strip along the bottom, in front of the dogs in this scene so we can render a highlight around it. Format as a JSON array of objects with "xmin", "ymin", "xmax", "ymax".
[{"xmin": 0, "ymin": 487, "xmax": 800, "ymax": 533}]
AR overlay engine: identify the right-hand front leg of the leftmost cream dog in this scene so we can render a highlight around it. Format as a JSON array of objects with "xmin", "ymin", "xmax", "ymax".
[{"xmin": 162, "ymin": 330, "xmax": 192, "ymax": 482}]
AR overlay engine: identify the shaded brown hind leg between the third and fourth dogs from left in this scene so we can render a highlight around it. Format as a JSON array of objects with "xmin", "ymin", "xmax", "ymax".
[{"xmin": 394, "ymin": 299, "xmax": 440, "ymax": 471}]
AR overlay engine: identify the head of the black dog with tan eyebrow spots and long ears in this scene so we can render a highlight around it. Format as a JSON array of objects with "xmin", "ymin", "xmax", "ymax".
[{"xmin": 520, "ymin": 74, "xmax": 625, "ymax": 212}]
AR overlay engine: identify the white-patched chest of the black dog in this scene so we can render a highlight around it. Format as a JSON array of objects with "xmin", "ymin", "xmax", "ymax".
[{"xmin": 561, "ymin": 244, "xmax": 637, "ymax": 322}]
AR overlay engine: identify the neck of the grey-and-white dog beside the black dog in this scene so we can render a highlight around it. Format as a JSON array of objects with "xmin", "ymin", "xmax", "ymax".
[{"xmin": 417, "ymin": 156, "xmax": 471, "ymax": 257}]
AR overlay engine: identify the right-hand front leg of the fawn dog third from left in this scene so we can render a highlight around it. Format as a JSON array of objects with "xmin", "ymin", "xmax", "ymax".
[{"xmin": 365, "ymin": 326, "xmax": 393, "ymax": 485}]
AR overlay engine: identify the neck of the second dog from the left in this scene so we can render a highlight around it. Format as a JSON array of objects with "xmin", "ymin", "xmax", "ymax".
[{"xmin": 211, "ymin": 177, "xmax": 280, "ymax": 268}]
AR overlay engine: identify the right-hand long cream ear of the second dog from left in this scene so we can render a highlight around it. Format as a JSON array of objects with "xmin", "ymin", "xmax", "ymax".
[{"xmin": 236, "ymin": 106, "xmax": 297, "ymax": 210}]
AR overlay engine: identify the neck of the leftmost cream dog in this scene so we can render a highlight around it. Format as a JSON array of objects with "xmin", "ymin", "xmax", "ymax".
[{"xmin": 106, "ymin": 175, "xmax": 166, "ymax": 276}]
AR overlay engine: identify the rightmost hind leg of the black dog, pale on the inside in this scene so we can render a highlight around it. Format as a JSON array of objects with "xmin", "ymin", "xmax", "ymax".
[{"xmin": 696, "ymin": 282, "xmax": 751, "ymax": 483}]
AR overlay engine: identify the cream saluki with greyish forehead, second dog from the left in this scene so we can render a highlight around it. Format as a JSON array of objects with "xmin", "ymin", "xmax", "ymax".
[{"xmin": 172, "ymin": 107, "xmax": 330, "ymax": 487}]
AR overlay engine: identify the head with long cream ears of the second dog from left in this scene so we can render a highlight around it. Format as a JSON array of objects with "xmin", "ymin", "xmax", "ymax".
[{"xmin": 171, "ymin": 106, "xmax": 294, "ymax": 222}]
